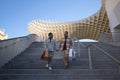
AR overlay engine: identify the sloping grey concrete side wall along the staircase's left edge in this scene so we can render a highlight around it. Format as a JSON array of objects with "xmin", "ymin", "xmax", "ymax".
[{"xmin": 0, "ymin": 34, "xmax": 38, "ymax": 67}]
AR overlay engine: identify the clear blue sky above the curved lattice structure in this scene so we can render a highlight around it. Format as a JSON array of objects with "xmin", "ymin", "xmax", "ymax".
[{"xmin": 0, "ymin": 0, "xmax": 101, "ymax": 38}]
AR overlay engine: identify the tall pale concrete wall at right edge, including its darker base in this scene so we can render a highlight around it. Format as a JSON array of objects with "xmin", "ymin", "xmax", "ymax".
[{"xmin": 105, "ymin": 0, "xmax": 120, "ymax": 42}]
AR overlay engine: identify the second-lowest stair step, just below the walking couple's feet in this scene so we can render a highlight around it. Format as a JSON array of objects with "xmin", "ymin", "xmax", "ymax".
[{"xmin": 0, "ymin": 69, "xmax": 118, "ymax": 75}]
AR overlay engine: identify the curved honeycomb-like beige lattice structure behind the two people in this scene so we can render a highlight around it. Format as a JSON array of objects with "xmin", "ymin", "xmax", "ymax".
[{"xmin": 28, "ymin": 0, "xmax": 120, "ymax": 41}]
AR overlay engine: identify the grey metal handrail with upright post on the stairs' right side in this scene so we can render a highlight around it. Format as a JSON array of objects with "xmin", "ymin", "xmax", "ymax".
[{"xmin": 70, "ymin": 33, "xmax": 120, "ymax": 72}]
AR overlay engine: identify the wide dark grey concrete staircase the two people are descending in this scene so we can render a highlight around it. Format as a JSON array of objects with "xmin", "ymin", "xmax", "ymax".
[{"xmin": 0, "ymin": 42, "xmax": 120, "ymax": 80}]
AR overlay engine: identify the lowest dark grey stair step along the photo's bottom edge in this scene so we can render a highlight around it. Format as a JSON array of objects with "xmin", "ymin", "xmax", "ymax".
[{"xmin": 0, "ymin": 74, "xmax": 120, "ymax": 80}]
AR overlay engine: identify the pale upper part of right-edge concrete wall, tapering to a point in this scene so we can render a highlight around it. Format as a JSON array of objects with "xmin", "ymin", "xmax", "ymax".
[{"xmin": 105, "ymin": 0, "xmax": 120, "ymax": 32}]
